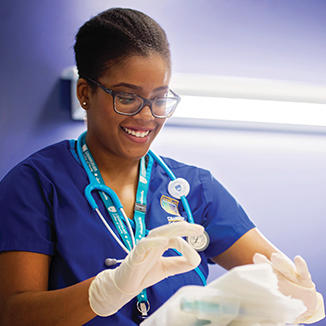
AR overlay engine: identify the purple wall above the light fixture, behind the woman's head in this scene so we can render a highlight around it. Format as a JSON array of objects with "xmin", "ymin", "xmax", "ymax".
[{"xmin": 0, "ymin": 0, "xmax": 326, "ymax": 176}]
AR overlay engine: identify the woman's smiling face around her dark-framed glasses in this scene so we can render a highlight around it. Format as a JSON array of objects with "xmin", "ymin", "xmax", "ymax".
[{"xmin": 87, "ymin": 53, "xmax": 170, "ymax": 160}]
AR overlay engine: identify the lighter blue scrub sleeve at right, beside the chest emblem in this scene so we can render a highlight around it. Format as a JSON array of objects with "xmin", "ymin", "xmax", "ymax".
[{"xmin": 202, "ymin": 172, "xmax": 255, "ymax": 258}]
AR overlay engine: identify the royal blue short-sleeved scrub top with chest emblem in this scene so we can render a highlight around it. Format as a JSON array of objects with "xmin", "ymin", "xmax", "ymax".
[{"xmin": 0, "ymin": 140, "xmax": 254, "ymax": 326}]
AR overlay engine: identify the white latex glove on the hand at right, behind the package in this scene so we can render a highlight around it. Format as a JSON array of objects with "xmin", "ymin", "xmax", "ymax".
[{"xmin": 254, "ymin": 252, "xmax": 325, "ymax": 324}]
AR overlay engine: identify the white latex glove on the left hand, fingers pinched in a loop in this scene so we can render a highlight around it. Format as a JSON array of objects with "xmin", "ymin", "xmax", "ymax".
[{"xmin": 88, "ymin": 222, "xmax": 204, "ymax": 316}]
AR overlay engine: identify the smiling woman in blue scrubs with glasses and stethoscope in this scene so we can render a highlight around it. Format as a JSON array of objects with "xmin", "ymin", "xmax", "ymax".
[{"xmin": 0, "ymin": 8, "xmax": 322, "ymax": 325}]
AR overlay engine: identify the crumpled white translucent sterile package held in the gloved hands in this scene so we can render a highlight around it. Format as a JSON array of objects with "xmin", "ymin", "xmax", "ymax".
[{"xmin": 141, "ymin": 264, "xmax": 306, "ymax": 326}]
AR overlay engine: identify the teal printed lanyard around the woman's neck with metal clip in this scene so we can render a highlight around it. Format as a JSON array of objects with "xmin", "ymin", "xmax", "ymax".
[{"xmin": 81, "ymin": 136, "xmax": 154, "ymax": 316}]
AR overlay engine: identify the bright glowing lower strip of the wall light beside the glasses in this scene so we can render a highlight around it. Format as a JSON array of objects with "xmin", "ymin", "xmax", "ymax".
[{"xmin": 169, "ymin": 95, "xmax": 326, "ymax": 126}]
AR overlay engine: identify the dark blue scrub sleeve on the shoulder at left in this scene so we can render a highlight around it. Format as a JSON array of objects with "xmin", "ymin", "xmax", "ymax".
[{"xmin": 0, "ymin": 164, "xmax": 54, "ymax": 255}]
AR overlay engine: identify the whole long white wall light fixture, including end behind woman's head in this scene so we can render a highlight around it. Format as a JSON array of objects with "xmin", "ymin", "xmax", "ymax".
[{"xmin": 61, "ymin": 66, "xmax": 326, "ymax": 132}]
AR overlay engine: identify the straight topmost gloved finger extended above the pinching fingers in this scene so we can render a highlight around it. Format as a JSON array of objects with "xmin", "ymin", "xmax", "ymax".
[{"xmin": 147, "ymin": 222, "xmax": 204, "ymax": 238}]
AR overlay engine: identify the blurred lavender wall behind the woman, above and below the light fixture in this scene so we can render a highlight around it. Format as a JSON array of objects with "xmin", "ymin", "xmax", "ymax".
[{"xmin": 0, "ymin": 0, "xmax": 326, "ymax": 325}]
